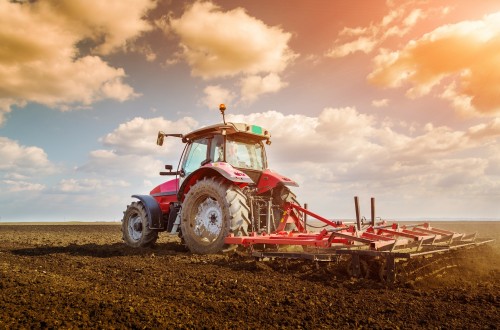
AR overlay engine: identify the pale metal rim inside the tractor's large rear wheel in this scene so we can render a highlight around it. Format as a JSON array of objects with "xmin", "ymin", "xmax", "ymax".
[{"xmin": 194, "ymin": 198, "xmax": 223, "ymax": 243}]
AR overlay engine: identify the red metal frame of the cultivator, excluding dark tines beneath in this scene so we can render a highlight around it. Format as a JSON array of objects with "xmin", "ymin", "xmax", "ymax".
[{"xmin": 225, "ymin": 197, "xmax": 492, "ymax": 281}]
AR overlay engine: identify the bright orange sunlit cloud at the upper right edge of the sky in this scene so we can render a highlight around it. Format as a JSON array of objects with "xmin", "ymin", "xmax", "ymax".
[{"xmin": 368, "ymin": 13, "xmax": 500, "ymax": 116}]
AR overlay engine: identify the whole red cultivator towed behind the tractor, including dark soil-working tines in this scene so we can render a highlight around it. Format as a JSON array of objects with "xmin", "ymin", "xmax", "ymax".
[{"xmin": 225, "ymin": 197, "xmax": 492, "ymax": 283}]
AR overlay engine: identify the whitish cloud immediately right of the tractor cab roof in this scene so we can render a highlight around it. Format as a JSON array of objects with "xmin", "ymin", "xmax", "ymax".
[{"xmin": 228, "ymin": 107, "xmax": 375, "ymax": 163}]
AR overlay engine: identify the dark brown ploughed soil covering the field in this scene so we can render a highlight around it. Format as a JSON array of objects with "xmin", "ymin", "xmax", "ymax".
[{"xmin": 0, "ymin": 224, "xmax": 500, "ymax": 329}]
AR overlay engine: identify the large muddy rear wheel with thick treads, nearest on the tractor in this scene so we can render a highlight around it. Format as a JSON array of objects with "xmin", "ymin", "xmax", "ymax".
[{"xmin": 181, "ymin": 178, "xmax": 250, "ymax": 254}]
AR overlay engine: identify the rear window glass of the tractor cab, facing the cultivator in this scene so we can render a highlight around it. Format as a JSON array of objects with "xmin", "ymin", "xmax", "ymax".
[{"xmin": 226, "ymin": 138, "xmax": 265, "ymax": 171}]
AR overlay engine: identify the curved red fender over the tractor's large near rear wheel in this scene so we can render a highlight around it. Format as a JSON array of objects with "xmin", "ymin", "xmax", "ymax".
[{"xmin": 177, "ymin": 162, "xmax": 254, "ymax": 201}]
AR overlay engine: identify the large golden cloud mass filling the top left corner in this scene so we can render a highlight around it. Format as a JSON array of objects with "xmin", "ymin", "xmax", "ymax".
[{"xmin": 0, "ymin": 0, "xmax": 154, "ymax": 119}]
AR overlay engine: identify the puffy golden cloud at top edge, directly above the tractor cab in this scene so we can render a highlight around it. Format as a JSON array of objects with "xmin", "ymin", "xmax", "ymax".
[{"xmin": 170, "ymin": 1, "xmax": 296, "ymax": 79}]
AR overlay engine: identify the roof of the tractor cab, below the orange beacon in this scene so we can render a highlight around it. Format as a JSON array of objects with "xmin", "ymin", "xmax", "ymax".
[{"xmin": 184, "ymin": 123, "xmax": 271, "ymax": 140}]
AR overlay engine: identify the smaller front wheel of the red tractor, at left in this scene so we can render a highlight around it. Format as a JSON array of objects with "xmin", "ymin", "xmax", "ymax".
[{"xmin": 122, "ymin": 202, "xmax": 158, "ymax": 248}]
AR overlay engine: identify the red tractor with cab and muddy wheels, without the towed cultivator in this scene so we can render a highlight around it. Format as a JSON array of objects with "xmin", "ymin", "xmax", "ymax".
[{"xmin": 122, "ymin": 104, "xmax": 302, "ymax": 254}]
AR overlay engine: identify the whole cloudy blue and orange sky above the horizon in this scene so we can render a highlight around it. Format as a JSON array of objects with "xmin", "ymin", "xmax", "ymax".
[{"xmin": 0, "ymin": 0, "xmax": 500, "ymax": 222}]
